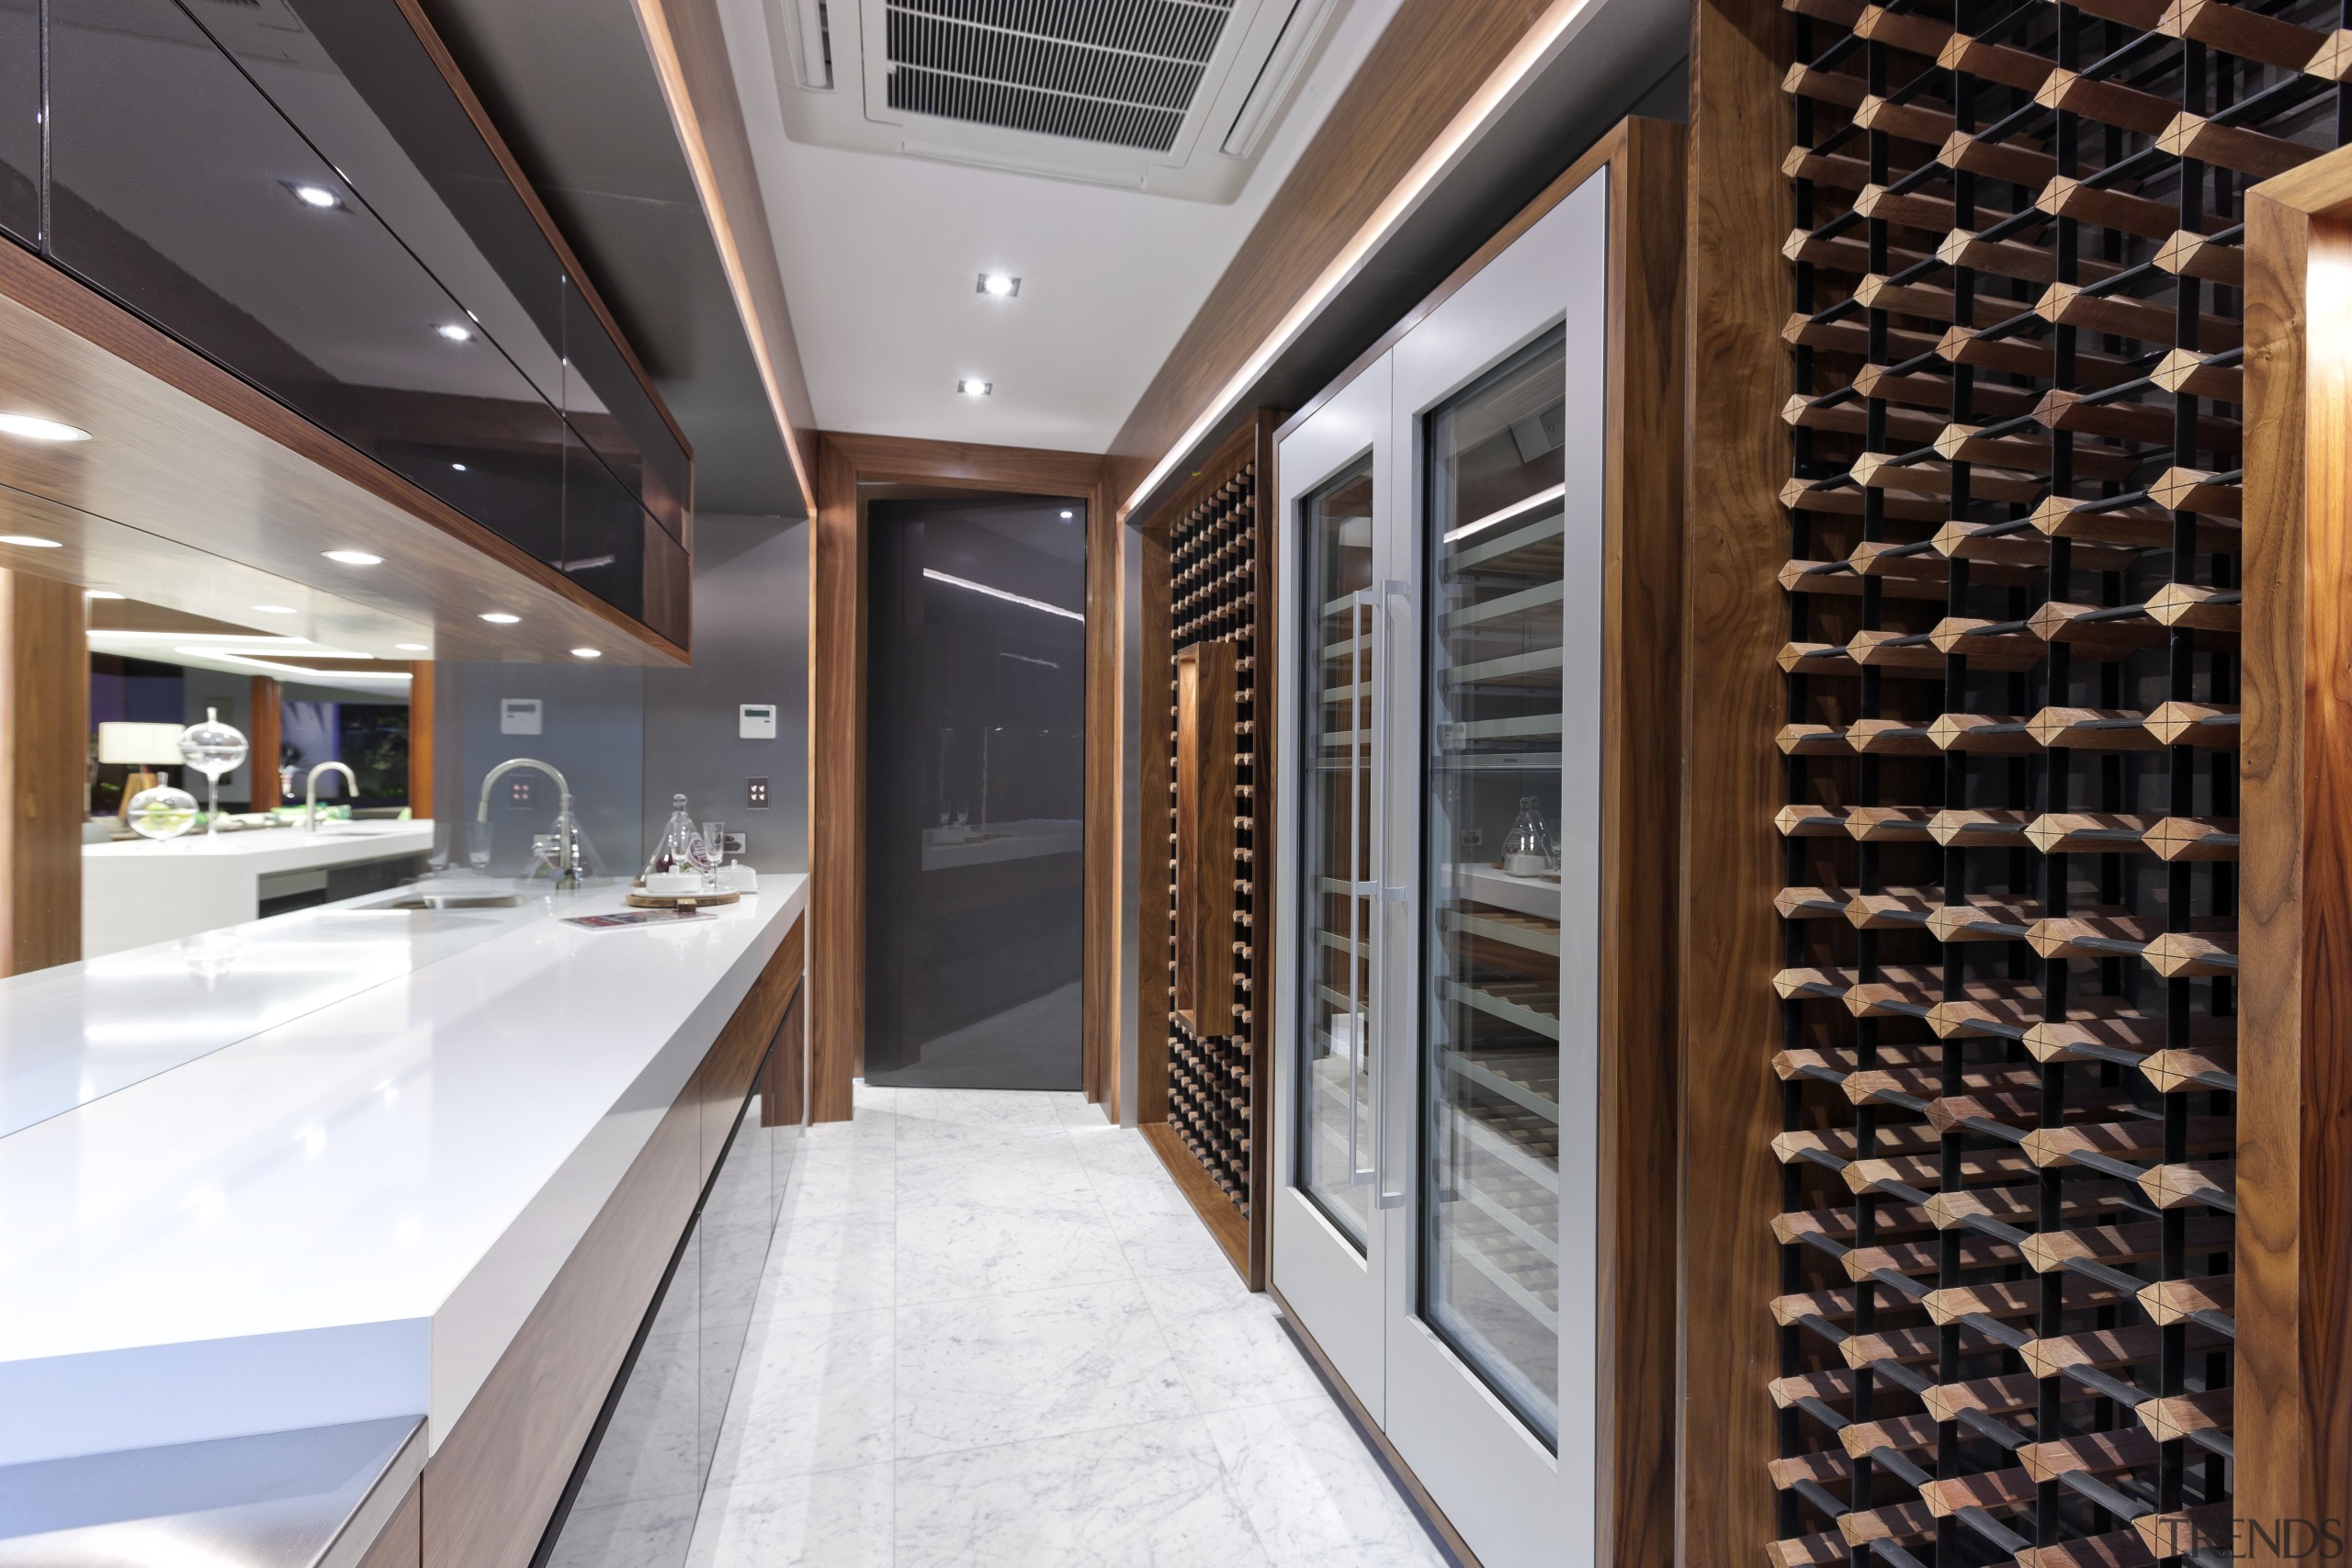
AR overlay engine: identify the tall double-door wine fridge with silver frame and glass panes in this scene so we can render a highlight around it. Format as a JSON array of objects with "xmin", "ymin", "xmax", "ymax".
[{"xmin": 1272, "ymin": 130, "xmax": 1679, "ymax": 1568}]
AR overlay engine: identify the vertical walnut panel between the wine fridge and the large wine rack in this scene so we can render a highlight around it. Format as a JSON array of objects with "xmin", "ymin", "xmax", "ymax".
[{"xmin": 1675, "ymin": 0, "xmax": 1790, "ymax": 1568}]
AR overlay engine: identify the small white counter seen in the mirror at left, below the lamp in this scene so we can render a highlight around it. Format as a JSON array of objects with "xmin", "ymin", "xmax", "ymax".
[{"xmin": 83, "ymin": 820, "xmax": 433, "ymax": 959}]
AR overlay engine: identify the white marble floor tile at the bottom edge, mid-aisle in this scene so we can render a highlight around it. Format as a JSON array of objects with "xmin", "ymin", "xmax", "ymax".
[{"xmin": 896, "ymin": 1416, "xmax": 1270, "ymax": 1568}]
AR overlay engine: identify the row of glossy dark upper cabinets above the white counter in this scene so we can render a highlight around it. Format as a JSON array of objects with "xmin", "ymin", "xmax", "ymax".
[{"xmin": 28, "ymin": 0, "xmax": 692, "ymax": 639}]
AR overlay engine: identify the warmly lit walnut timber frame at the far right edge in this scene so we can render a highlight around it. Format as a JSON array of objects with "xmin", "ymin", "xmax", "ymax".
[{"xmin": 2232, "ymin": 151, "xmax": 2352, "ymax": 1561}]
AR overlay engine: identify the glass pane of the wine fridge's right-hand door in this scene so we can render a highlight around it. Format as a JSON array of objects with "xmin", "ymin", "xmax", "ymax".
[{"xmin": 1420, "ymin": 332, "xmax": 1566, "ymax": 1443}]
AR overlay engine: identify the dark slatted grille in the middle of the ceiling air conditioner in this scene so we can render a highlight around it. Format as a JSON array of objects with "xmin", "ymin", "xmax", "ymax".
[{"xmin": 887, "ymin": 0, "xmax": 1232, "ymax": 152}]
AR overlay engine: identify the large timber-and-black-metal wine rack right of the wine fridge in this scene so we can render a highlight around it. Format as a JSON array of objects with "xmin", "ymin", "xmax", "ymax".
[{"xmin": 1769, "ymin": 0, "xmax": 2295, "ymax": 1568}]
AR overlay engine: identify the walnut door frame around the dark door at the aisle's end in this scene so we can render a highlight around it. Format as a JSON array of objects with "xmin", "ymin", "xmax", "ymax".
[{"xmin": 809, "ymin": 430, "xmax": 1120, "ymax": 1122}]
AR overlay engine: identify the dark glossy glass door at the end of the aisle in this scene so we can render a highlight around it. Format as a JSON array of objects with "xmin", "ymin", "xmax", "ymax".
[{"xmin": 865, "ymin": 487, "xmax": 1087, "ymax": 1089}]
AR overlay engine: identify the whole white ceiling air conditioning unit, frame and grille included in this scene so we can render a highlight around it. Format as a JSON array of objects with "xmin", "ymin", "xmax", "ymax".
[{"xmin": 767, "ymin": 0, "xmax": 1348, "ymax": 202}]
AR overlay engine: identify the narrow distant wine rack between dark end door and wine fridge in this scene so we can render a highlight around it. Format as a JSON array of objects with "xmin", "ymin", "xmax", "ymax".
[{"xmin": 1155, "ymin": 413, "xmax": 1272, "ymax": 1286}]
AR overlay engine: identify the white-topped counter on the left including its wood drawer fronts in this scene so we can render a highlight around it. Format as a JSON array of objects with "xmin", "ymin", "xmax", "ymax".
[{"xmin": 0, "ymin": 877, "xmax": 807, "ymax": 1568}]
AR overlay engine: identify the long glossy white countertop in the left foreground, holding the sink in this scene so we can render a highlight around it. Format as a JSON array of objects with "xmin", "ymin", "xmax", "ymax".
[{"xmin": 0, "ymin": 877, "xmax": 807, "ymax": 1464}]
